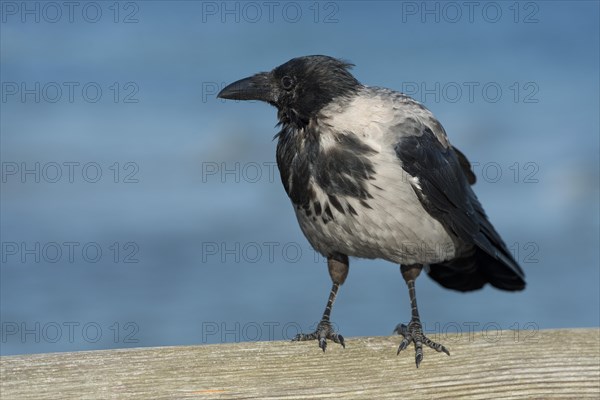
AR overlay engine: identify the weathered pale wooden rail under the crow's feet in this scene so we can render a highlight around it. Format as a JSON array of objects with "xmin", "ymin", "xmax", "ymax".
[{"xmin": 0, "ymin": 329, "xmax": 600, "ymax": 399}]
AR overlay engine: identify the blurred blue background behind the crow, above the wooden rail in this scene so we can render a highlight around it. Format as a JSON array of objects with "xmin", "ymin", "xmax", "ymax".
[{"xmin": 0, "ymin": 1, "xmax": 600, "ymax": 355}]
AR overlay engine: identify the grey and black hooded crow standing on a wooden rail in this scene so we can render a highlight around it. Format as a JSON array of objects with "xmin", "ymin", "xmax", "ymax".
[{"xmin": 218, "ymin": 55, "xmax": 525, "ymax": 367}]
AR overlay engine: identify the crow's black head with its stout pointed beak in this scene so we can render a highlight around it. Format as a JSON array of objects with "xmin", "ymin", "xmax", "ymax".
[{"xmin": 218, "ymin": 56, "xmax": 360, "ymax": 127}]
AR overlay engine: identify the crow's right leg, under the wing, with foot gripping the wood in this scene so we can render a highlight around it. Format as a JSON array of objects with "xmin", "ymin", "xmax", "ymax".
[{"xmin": 394, "ymin": 264, "xmax": 450, "ymax": 368}]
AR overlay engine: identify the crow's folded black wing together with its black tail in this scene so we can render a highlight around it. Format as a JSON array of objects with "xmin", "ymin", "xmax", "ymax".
[{"xmin": 395, "ymin": 126, "xmax": 525, "ymax": 291}]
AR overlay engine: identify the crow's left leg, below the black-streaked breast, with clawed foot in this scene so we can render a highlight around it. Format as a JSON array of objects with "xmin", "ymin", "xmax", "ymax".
[{"xmin": 292, "ymin": 254, "xmax": 349, "ymax": 351}]
